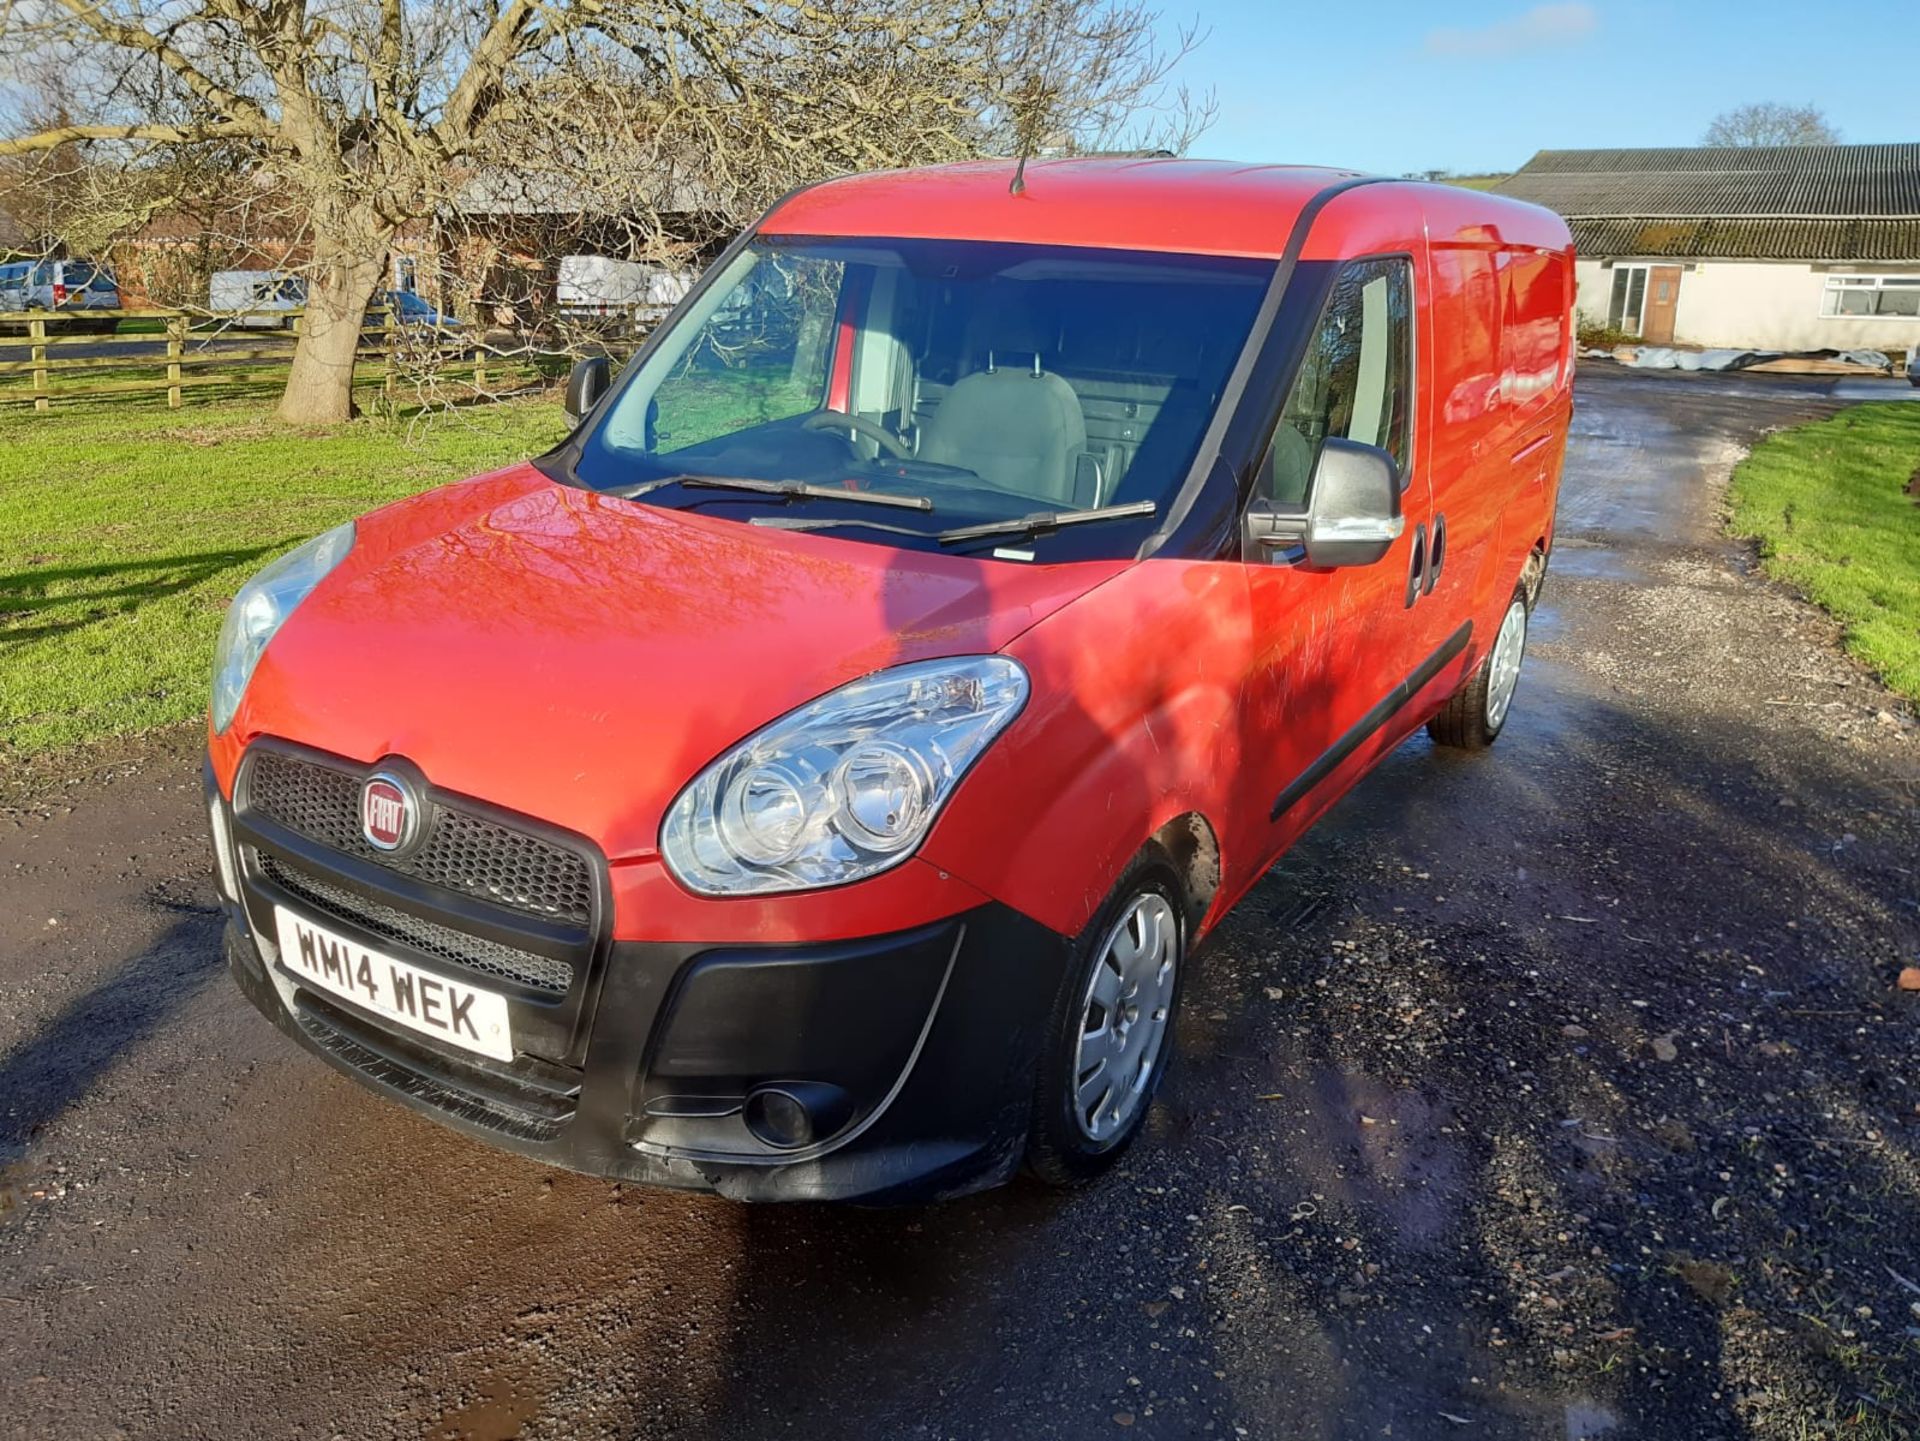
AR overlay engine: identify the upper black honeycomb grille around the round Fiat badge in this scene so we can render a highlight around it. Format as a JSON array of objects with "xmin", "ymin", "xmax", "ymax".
[{"xmin": 246, "ymin": 750, "xmax": 593, "ymax": 929}]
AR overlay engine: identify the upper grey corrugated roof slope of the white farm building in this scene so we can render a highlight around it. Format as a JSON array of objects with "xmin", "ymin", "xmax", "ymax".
[{"xmin": 1494, "ymin": 144, "xmax": 1920, "ymax": 221}]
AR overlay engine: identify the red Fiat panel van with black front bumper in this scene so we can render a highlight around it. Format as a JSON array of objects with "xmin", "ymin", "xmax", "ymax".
[{"xmin": 207, "ymin": 159, "xmax": 1572, "ymax": 1201}]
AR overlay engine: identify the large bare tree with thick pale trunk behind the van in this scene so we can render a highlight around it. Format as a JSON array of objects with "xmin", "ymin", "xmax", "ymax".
[{"xmin": 0, "ymin": 0, "xmax": 1192, "ymax": 422}]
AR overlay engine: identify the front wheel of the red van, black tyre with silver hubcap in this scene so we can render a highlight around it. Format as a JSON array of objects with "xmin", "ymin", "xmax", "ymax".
[{"xmin": 1027, "ymin": 846, "xmax": 1187, "ymax": 1186}]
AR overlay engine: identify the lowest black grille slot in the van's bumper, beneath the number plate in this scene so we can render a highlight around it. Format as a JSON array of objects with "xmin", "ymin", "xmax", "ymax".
[{"xmin": 294, "ymin": 992, "xmax": 578, "ymax": 1142}]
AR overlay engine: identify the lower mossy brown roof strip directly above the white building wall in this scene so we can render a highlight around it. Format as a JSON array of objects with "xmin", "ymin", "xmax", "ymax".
[{"xmin": 1567, "ymin": 215, "xmax": 1920, "ymax": 263}]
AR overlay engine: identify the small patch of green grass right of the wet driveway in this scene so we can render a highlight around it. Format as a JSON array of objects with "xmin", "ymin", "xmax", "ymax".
[{"xmin": 1734, "ymin": 403, "xmax": 1920, "ymax": 700}]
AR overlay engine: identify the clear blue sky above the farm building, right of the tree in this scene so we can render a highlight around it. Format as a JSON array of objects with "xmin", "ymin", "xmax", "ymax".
[{"xmin": 1158, "ymin": 0, "xmax": 1920, "ymax": 175}]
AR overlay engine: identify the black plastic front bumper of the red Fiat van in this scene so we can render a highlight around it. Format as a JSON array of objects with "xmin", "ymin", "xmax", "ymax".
[{"xmin": 220, "ymin": 755, "xmax": 1068, "ymax": 1203}]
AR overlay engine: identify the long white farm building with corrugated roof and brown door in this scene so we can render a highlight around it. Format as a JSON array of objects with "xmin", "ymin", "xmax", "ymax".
[{"xmin": 1496, "ymin": 144, "xmax": 1920, "ymax": 355}]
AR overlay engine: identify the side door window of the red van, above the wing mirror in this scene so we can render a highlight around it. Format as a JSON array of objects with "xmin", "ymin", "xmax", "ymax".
[{"xmin": 1260, "ymin": 257, "xmax": 1413, "ymax": 508}]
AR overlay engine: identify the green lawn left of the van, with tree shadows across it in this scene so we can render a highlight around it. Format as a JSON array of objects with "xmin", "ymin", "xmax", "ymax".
[{"xmin": 0, "ymin": 401, "xmax": 566, "ymax": 760}]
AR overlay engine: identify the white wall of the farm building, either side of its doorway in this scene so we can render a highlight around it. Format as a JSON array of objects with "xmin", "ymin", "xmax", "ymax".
[{"xmin": 1574, "ymin": 259, "xmax": 1920, "ymax": 359}]
